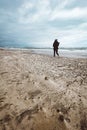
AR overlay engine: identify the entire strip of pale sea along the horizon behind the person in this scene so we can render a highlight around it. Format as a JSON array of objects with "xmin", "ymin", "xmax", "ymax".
[{"xmin": 0, "ymin": 47, "xmax": 87, "ymax": 58}]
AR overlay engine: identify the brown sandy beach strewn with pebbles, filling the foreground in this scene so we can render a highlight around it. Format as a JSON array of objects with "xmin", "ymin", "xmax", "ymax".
[{"xmin": 0, "ymin": 49, "xmax": 87, "ymax": 130}]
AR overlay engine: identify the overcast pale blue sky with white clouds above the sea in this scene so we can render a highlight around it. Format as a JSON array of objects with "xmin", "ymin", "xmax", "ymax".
[{"xmin": 0, "ymin": 0, "xmax": 87, "ymax": 47}]
